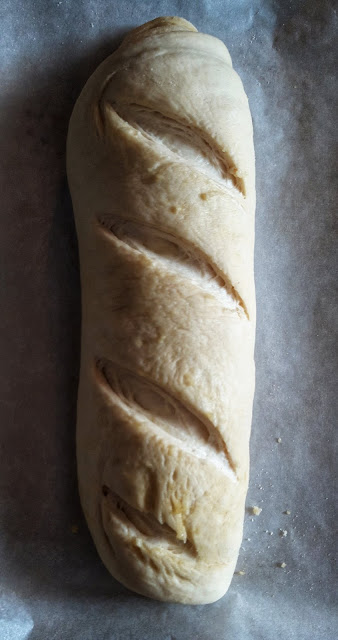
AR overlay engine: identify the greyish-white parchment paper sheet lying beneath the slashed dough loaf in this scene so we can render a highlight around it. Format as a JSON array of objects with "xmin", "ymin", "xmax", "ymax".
[{"xmin": 0, "ymin": 0, "xmax": 337, "ymax": 640}]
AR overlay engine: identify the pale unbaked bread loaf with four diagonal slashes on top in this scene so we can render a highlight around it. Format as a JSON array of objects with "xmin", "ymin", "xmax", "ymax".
[{"xmin": 67, "ymin": 18, "xmax": 255, "ymax": 604}]
